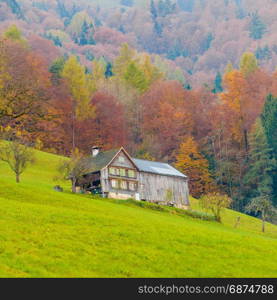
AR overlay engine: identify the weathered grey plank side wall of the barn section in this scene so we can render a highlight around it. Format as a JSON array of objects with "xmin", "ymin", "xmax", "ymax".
[{"xmin": 138, "ymin": 172, "xmax": 189, "ymax": 207}]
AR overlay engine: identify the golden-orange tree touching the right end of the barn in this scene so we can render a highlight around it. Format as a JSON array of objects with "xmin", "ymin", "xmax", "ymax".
[{"xmin": 175, "ymin": 137, "xmax": 213, "ymax": 198}]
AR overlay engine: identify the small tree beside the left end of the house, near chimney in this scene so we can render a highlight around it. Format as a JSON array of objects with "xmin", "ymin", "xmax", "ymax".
[{"xmin": 58, "ymin": 150, "xmax": 88, "ymax": 193}]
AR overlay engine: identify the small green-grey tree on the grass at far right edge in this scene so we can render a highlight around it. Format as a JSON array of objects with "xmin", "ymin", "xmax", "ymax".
[{"xmin": 246, "ymin": 195, "xmax": 276, "ymax": 232}]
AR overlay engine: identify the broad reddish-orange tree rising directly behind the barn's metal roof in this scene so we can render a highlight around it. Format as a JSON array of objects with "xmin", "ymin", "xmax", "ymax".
[{"xmin": 141, "ymin": 81, "xmax": 193, "ymax": 158}]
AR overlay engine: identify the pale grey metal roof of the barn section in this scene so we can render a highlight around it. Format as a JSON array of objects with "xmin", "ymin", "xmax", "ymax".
[{"xmin": 133, "ymin": 158, "xmax": 187, "ymax": 178}]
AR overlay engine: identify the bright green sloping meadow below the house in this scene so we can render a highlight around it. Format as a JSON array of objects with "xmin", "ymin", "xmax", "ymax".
[{"xmin": 0, "ymin": 152, "xmax": 277, "ymax": 277}]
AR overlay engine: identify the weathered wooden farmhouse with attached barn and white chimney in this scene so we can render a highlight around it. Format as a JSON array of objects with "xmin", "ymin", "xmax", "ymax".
[{"xmin": 77, "ymin": 147, "xmax": 189, "ymax": 208}]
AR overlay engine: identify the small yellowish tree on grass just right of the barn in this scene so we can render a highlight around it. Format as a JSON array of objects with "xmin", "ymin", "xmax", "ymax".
[{"xmin": 201, "ymin": 193, "xmax": 232, "ymax": 222}]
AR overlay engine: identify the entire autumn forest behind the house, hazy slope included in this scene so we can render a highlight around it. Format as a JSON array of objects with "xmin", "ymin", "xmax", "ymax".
[{"xmin": 0, "ymin": 0, "xmax": 277, "ymax": 216}]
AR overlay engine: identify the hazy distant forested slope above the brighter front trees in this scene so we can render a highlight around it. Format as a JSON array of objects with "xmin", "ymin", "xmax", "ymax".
[{"xmin": 0, "ymin": 0, "xmax": 277, "ymax": 86}]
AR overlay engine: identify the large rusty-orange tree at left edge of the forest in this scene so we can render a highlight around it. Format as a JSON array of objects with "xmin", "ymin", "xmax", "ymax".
[{"xmin": 0, "ymin": 39, "xmax": 51, "ymax": 144}]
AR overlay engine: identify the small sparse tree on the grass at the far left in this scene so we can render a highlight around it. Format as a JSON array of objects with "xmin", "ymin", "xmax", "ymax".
[{"xmin": 0, "ymin": 141, "xmax": 35, "ymax": 183}]
